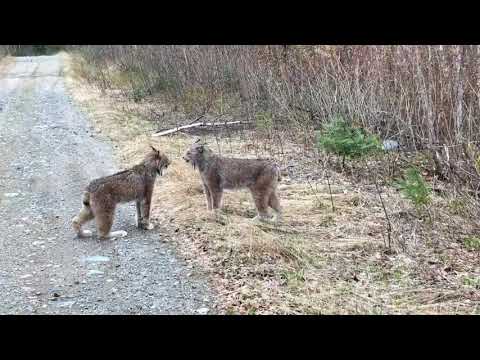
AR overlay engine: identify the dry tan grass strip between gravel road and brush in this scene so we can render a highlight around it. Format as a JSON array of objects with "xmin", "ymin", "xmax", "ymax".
[{"xmin": 65, "ymin": 55, "xmax": 480, "ymax": 314}]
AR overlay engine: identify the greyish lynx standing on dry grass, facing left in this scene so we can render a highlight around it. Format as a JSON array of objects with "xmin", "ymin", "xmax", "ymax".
[{"xmin": 183, "ymin": 141, "xmax": 282, "ymax": 221}]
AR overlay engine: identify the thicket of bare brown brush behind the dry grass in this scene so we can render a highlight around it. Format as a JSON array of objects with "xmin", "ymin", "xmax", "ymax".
[{"xmin": 66, "ymin": 45, "xmax": 480, "ymax": 195}]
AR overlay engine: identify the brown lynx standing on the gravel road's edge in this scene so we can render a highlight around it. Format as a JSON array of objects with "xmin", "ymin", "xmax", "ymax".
[{"xmin": 72, "ymin": 146, "xmax": 170, "ymax": 239}]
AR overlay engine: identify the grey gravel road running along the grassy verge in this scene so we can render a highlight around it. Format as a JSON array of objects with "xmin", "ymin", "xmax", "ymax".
[{"xmin": 0, "ymin": 56, "xmax": 213, "ymax": 314}]
